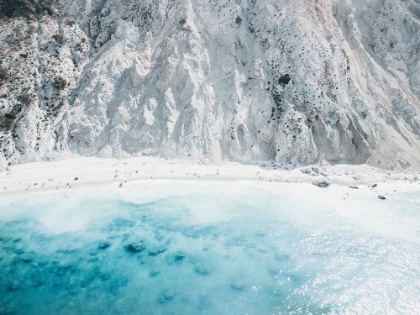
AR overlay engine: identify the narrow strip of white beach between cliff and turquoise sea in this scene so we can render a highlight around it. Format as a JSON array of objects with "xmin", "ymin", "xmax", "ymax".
[{"xmin": 0, "ymin": 157, "xmax": 420, "ymax": 197}]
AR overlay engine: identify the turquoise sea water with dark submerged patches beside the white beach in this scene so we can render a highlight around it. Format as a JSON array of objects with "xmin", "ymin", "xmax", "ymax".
[{"xmin": 0, "ymin": 184, "xmax": 420, "ymax": 315}]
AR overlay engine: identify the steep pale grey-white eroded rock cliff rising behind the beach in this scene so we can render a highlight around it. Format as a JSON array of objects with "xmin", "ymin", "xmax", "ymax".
[{"xmin": 0, "ymin": 0, "xmax": 420, "ymax": 169}]
